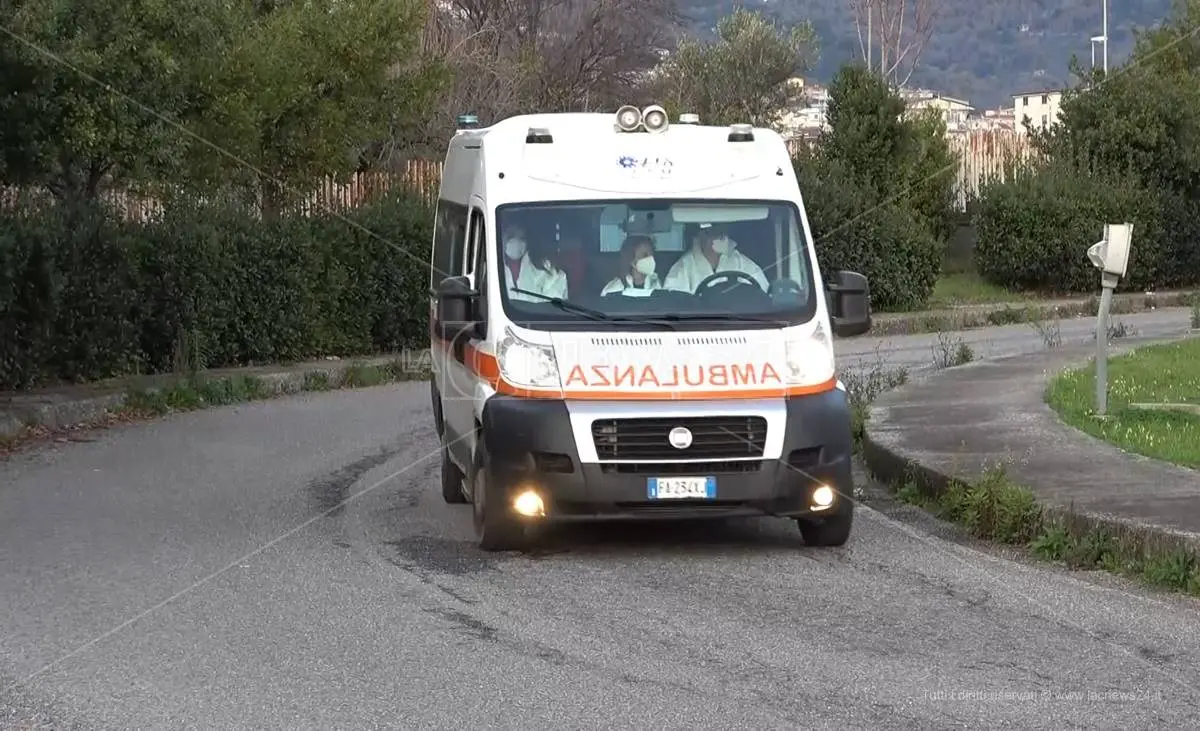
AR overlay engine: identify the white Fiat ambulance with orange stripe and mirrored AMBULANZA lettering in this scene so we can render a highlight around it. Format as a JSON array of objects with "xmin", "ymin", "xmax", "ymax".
[{"xmin": 430, "ymin": 106, "xmax": 871, "ymax": 551}]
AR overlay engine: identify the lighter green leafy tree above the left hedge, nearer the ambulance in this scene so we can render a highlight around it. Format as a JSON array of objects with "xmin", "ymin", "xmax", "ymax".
[{"xmin": 190, "ymin": 0, "xmax": 446, "ymax": 215}]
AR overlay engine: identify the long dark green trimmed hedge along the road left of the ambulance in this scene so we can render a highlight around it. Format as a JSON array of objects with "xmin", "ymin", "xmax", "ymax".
[{"xmin": 0, "ymin": 192, "xmax": 432, "ymax": 389}]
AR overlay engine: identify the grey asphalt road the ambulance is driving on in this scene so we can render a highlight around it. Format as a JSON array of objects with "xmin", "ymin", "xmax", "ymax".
[{"xmin": 0, "ymin": 304, "xmax": 1200, "ymax": 730}]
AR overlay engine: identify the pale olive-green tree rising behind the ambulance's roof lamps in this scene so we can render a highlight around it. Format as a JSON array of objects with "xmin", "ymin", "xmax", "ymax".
[{"xmin": 656, "ymin": 8, "xmax": 817, "ymax": 126}]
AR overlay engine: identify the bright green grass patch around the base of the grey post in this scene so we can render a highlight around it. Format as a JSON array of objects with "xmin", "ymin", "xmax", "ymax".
[{"xmin": 1046, "ymin": 337, "xmax": 1200, "ymax": 468}]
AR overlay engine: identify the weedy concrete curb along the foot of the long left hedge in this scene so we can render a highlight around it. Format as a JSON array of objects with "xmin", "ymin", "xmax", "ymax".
[{"xmin": 0, "ymin": 350, "xmax": 430, "ymax": 439}]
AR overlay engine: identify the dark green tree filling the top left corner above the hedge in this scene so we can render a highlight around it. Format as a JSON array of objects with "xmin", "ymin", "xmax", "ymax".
[{"xmin": 0, "ymin": 0, "xmax": 236, "ymax": 199}]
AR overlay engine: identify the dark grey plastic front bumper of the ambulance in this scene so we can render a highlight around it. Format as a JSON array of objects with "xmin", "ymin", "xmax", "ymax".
[{"xmin": 482, "ymin": 390, "xmax": 853, "ymax": 522}]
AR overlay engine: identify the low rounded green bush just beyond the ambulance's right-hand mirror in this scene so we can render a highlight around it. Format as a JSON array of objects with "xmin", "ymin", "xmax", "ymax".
[{"xmin": 796, "ymin": 156, "xmax": 946, "ymax": 311}]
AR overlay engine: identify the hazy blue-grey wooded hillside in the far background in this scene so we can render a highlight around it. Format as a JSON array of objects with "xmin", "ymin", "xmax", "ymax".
[{"xmin": 680, "ymin": 0, "xmax": 1172, "ymax": 107}]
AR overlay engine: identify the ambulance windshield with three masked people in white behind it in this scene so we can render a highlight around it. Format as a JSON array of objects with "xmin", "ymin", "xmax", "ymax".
[{"xmin": 496, "ymin": 199, "xmax": 816, "ymax": 330}]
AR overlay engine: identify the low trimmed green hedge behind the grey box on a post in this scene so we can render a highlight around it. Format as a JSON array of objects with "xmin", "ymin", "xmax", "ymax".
[{"xmin": 974, "ymin": 164, "xmax": 1200, "ymax": 293}]
